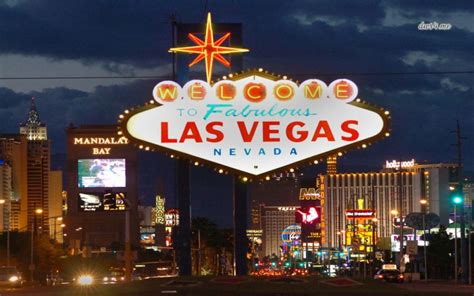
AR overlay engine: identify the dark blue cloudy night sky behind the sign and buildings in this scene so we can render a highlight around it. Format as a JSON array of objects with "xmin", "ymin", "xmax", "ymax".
[{"xmin": 0, "ymin": 0, "xmax": 474, "ymax": 226}]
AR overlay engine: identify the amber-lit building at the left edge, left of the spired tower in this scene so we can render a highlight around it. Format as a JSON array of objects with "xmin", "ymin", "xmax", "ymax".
[{"xmin": 0, "ymin": 134, "xmax": 28, "ymax": 231}]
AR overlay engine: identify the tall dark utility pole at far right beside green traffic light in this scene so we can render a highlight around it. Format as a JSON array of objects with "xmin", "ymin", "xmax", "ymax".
[{"xmin": 456, "ymin": 120, "xmax": 471, "ymax": 285}]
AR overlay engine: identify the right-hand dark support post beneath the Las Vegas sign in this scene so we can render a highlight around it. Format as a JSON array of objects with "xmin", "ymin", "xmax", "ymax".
[{"xmin": 234, "ymin": 175, "xmax": 248, "ymax": 275}]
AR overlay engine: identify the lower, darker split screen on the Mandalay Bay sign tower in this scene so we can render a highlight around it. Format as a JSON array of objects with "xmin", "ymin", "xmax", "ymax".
[{"xmin": 79, "ymin": 192, "xmax": 125, "ymax": 212}]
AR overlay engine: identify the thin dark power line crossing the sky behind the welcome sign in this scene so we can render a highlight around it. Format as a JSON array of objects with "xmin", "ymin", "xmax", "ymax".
[{"xmin": 0, "ymin": 70, "xmax": 474, "ymax": 80}]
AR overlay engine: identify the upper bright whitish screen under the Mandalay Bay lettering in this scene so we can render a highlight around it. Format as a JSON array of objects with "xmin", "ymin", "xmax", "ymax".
[{"xmin": 77, "ymin": 158, "xmax": 126, "ymax": 188}]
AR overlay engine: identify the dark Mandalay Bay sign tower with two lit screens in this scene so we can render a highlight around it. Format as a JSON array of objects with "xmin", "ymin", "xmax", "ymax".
[{"xmin": 65, "ymin": 125, "xmax": 139, "ymax": 252}]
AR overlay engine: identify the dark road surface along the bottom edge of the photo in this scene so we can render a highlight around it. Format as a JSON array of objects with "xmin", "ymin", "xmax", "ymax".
[{"xmin": 0, "ymin": 277, "xmax": 474, "ymax": 296}]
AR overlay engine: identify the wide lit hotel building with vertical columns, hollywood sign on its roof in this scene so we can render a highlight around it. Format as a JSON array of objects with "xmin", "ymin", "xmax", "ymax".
[{"xmin": 318, "ymin": 160, "xmax": 456, "ymax": 247}]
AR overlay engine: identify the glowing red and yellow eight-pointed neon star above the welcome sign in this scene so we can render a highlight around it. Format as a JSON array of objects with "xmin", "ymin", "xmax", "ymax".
[{"xmin": 170, "ymin": 12, "xmax": 249, "ymax": 83}]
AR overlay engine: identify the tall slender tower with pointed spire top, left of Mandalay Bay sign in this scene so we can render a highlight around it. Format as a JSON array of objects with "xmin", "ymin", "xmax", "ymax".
[{"xmin": 20, "ymin": 98, "xmax": 51, "ymax": 233}]
